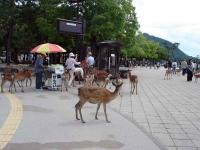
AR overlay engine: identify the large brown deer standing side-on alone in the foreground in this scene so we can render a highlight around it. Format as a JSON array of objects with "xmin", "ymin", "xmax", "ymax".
[{"xmin": 75, "ymin": 79, "xmax": 123, "ymax": 123}]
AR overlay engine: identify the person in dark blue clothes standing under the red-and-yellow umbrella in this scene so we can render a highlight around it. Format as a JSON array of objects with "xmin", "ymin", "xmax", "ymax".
[{"xmin": 35, "ymin": 52, "xmax": 46, "ymax": 89}]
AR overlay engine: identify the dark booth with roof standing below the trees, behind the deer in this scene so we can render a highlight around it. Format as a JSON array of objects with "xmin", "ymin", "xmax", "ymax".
[{"xmin": 95, "ymin": 41, "xmax": 122, "ymax": 77}]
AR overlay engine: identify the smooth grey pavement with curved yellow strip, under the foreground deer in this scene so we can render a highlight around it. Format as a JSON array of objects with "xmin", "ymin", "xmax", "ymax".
[{"xmin": 0, "ymin": 68, "xmax": 162, "ymax": 150}]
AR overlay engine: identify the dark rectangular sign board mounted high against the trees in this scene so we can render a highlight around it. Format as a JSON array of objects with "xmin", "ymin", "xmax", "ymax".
[{"xmin": 57, "ymin": 19, "xmax": 84, "ymax": 34}]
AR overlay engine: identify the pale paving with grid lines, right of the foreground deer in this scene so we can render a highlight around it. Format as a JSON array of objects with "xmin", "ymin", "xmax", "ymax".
[{"xmin": 110, "ymin": 67, "xmax": 200, "ymax": 150}]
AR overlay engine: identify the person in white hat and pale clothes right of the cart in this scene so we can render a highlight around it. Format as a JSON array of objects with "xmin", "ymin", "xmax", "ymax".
[{"xmin": 65, "ymin": 52, "xmax": 83, "ymax": 86}]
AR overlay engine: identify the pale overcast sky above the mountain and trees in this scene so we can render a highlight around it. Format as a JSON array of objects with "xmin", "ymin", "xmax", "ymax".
[{"xmin": 133, "ymin": 0, "xmax": 200, "ymax": 57}]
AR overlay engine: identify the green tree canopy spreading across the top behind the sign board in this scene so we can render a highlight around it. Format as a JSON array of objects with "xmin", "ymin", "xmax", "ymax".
[{"xmin": 0, "ymin": 0, "xmax": 168, "ymax": 63}]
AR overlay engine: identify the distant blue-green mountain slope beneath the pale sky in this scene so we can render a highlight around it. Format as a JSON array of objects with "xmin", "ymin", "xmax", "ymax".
[{"xmin": 143, "ymin": 33, "xmax": 191, "ymax": 60}]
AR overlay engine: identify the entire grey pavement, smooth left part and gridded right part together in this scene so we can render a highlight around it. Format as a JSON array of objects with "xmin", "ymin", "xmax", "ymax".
[{"xmin": 0, "ymin": 67, "xmax": 200, "ymax": 150}]
